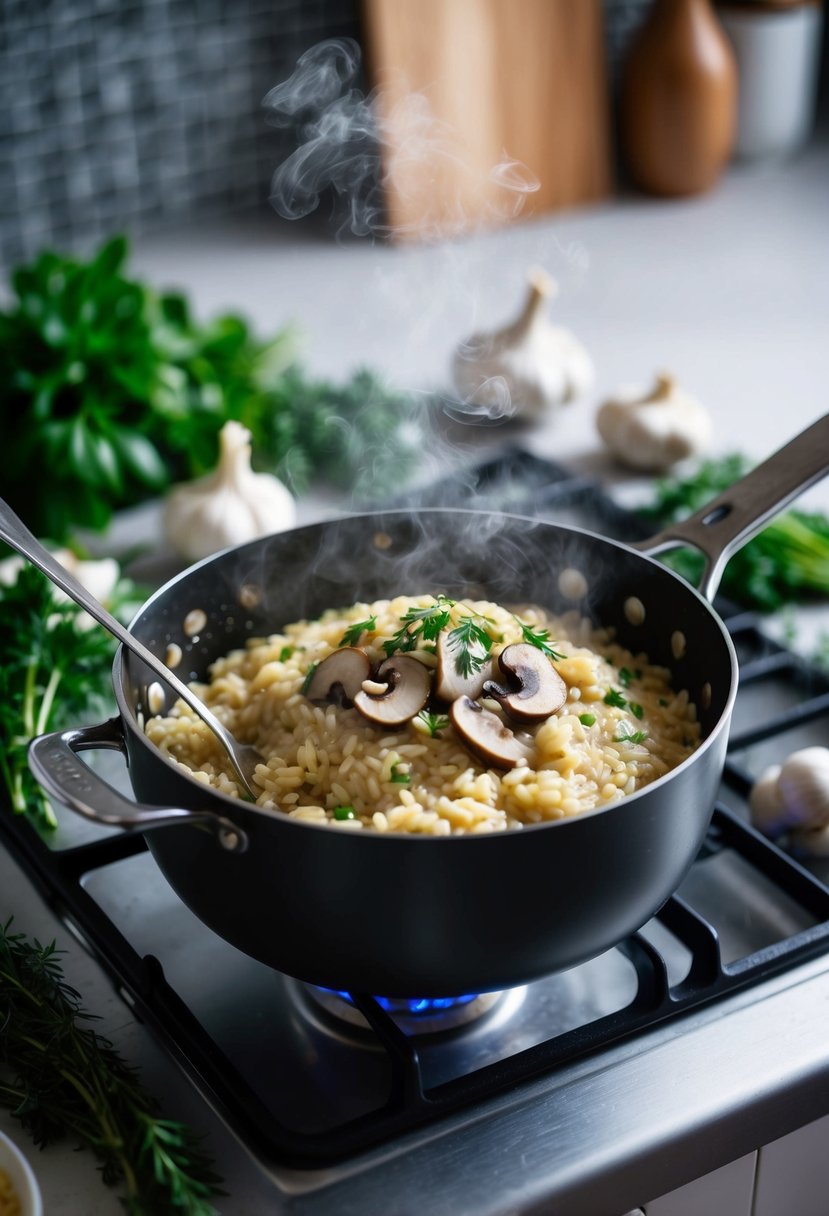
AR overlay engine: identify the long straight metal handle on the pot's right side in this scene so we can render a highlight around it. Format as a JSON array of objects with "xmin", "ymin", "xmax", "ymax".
[{"xmin": 631, "ymin": 413, "xmax": 829, "ymax": 601}]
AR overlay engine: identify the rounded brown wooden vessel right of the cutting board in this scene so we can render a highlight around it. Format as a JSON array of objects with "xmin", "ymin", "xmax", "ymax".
[{"xmin": 620, "ymin": 0, "xmax": 737, "ymax": 196}]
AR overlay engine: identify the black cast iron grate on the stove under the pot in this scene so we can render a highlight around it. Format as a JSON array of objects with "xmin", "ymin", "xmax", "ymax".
[{"xmin": 0, "ymin": 452, "xmax": 829, "ymax": 1167}]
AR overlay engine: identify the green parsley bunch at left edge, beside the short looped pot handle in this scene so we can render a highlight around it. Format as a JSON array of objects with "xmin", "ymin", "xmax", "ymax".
[{"xmin": 0, "ymin": 564, "xmax": 131, "ymax": 831}]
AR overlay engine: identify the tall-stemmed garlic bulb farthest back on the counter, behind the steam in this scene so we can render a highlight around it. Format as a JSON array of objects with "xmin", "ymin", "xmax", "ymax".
[{"xmin": 452, "ymin": 270, "xmax": 593, "ymax": 420}]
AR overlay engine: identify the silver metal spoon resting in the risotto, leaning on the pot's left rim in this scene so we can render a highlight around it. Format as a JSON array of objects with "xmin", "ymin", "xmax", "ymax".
[{"xmin": 0, "ymin": 499, "xmax": 263, "ymax": 800}]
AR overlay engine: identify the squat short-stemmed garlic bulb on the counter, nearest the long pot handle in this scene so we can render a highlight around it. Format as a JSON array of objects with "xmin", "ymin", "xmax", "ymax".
[{"xmin": 596, "ymin": 373, "xmax": 712, "ymax": 473}]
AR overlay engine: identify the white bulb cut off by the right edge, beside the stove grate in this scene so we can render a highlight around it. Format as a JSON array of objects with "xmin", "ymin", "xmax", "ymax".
[{"xmin": 749, "ymin": 747, "xmax": 829, "ymax": 855}]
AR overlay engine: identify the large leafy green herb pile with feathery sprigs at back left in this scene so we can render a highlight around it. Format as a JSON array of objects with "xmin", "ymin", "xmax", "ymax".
[{"xmin": 0, "ymin": 237, "xmax": 416, "ymax": 541}]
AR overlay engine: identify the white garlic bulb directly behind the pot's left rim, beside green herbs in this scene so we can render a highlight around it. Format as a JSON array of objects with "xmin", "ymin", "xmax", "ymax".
[{"xmin": 164, "ymin": 422, "xmax": 297, "ymax": 561}]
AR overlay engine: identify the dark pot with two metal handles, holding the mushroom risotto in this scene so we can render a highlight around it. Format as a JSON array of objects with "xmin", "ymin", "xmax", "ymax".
[{"xmin": 30, "ymin": 415, "xmax": 829, "ymax": 997}]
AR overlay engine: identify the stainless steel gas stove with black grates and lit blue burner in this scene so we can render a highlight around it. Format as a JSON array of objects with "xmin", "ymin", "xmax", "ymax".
[{"xmin": 0, "ymin": 451, "xmax": 829, "ymax": 1214}]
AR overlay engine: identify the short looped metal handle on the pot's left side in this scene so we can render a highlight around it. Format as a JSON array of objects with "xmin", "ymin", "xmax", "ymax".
[{"xmin": 29, "ymin": 717, "xmax": 248, "ymax": 852}]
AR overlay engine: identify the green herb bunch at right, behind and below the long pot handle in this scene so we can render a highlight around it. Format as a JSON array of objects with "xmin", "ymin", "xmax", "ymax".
[{"xmin": 644, "ymin": 455, "xmax": 829, "ymax": 612}]
